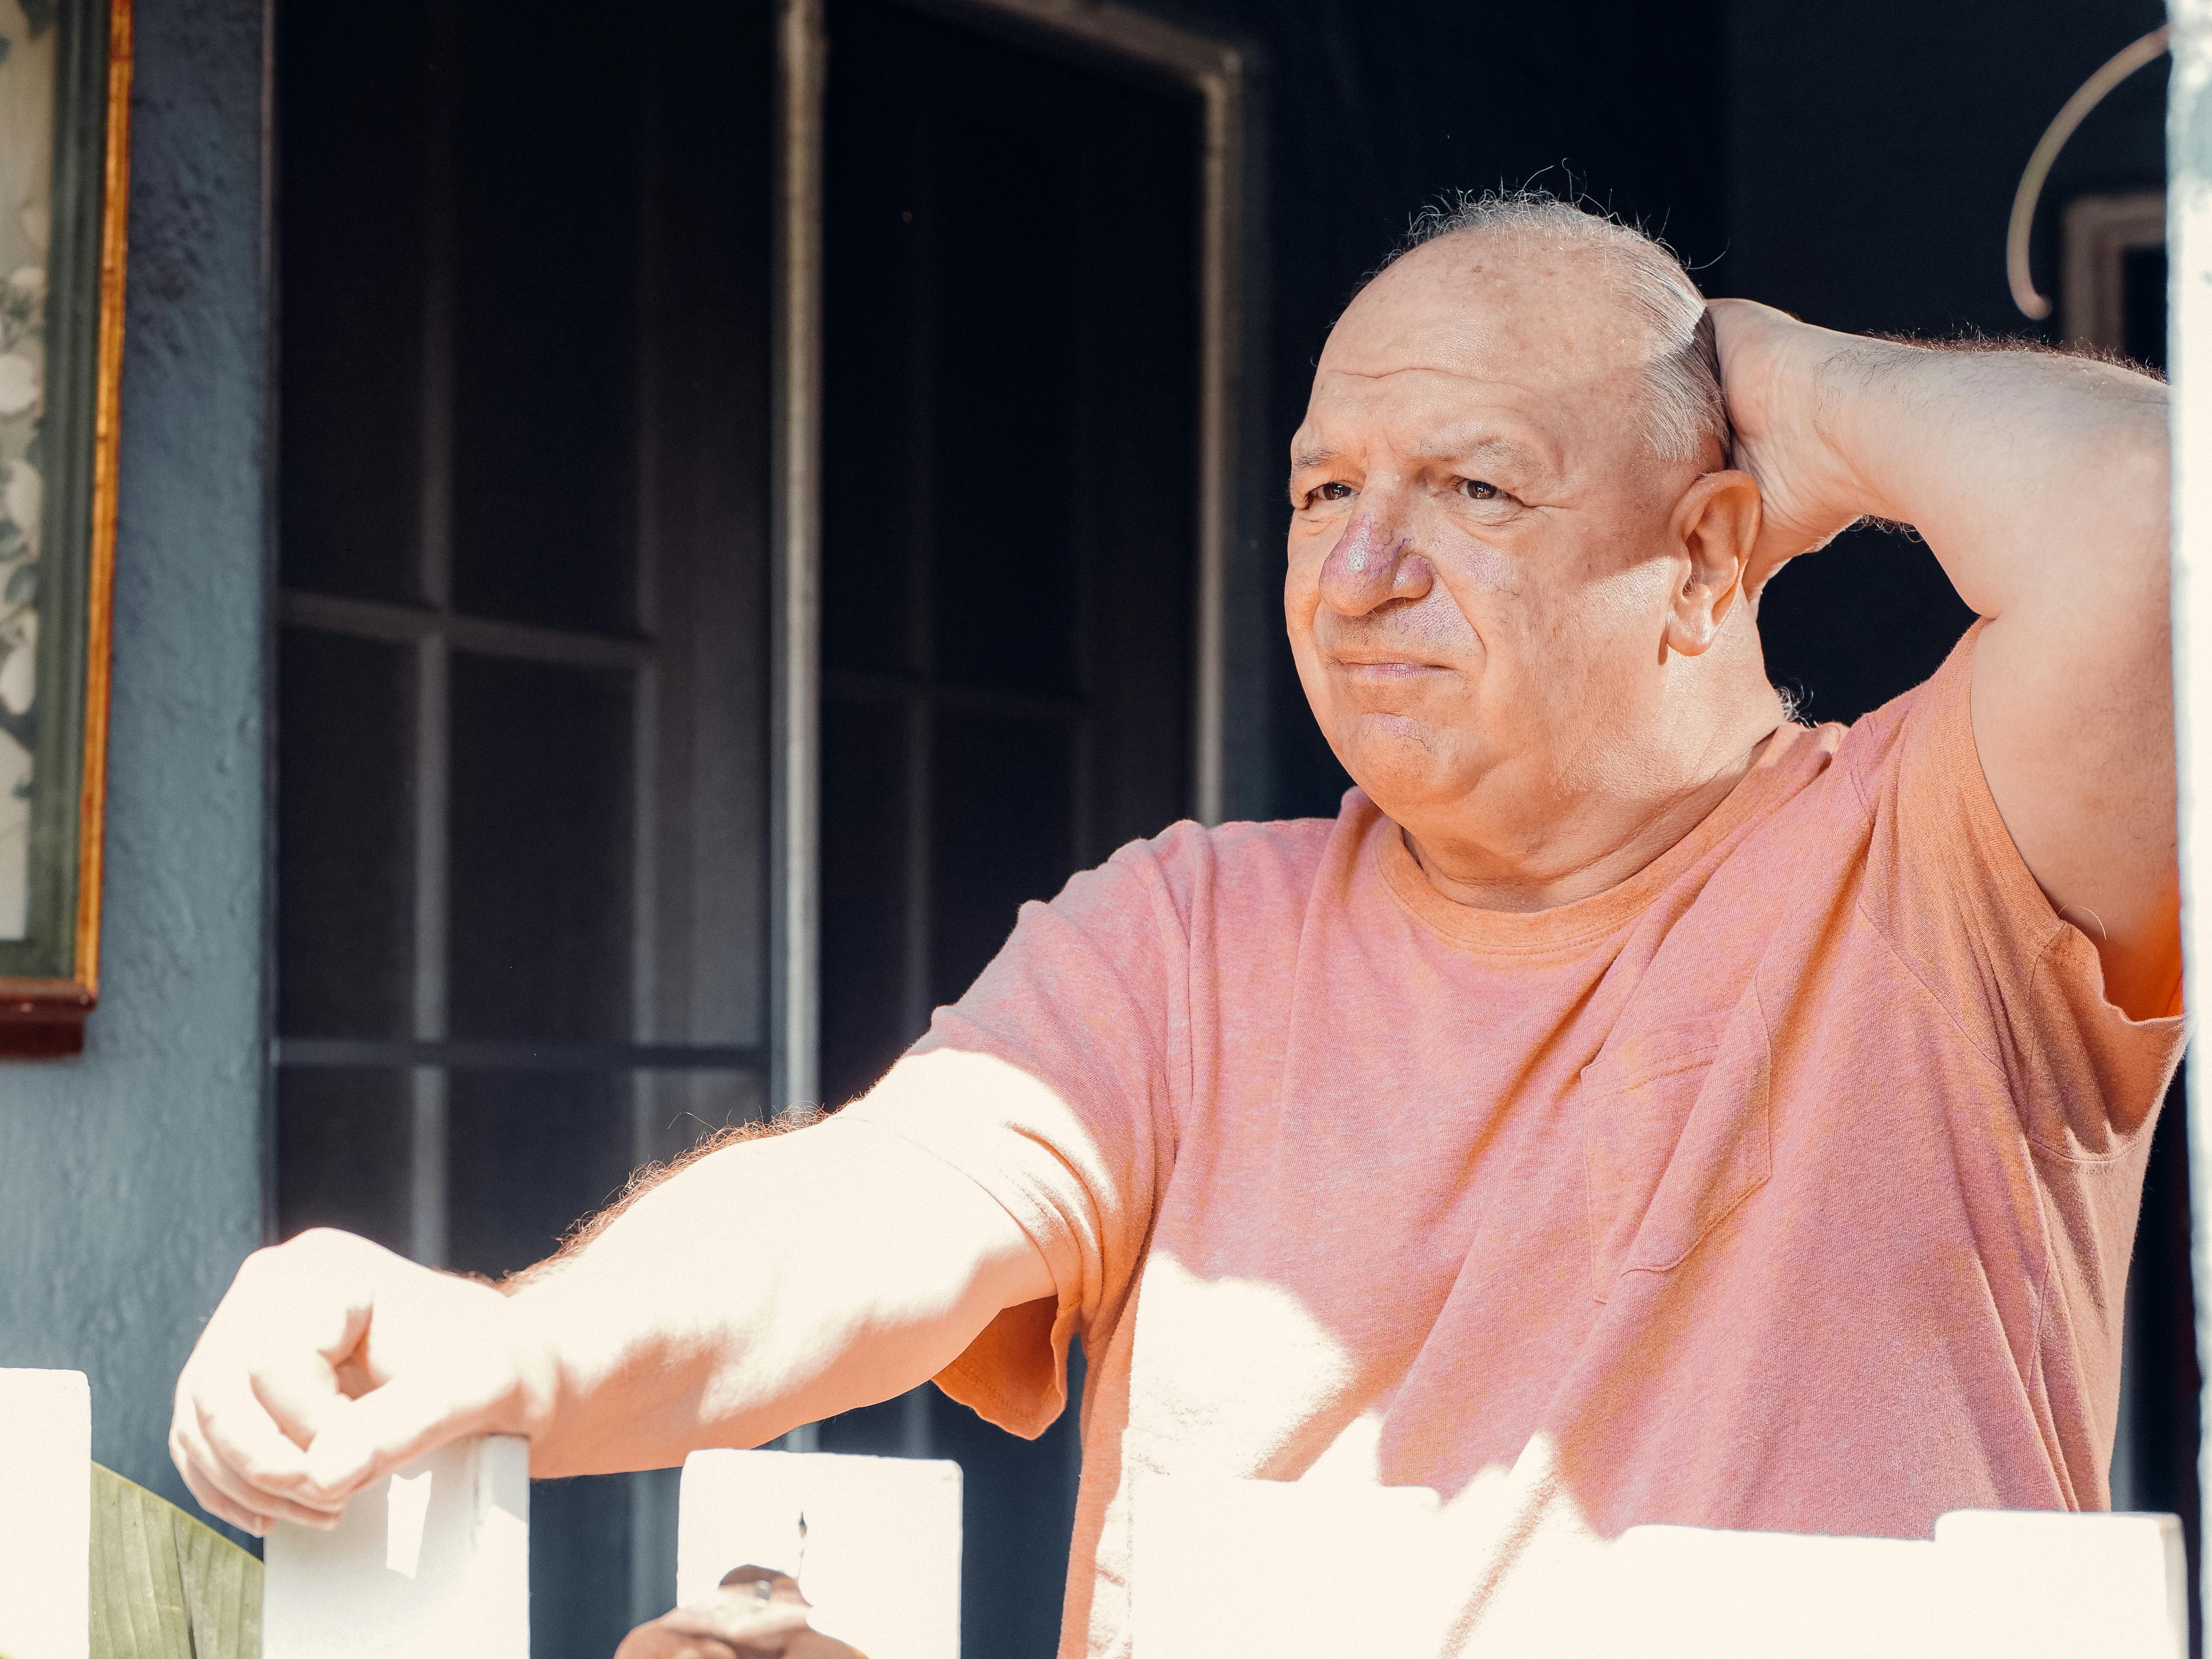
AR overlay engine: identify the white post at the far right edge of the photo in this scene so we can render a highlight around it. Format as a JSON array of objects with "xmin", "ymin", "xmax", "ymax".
[{"xmin": 2165, "ymin": 0, "xmax": 2212, "ymax": 1604}]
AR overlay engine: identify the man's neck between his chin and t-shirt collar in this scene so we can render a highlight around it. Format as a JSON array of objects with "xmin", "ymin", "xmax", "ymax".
[{"xmin": 1400, "ymin": 681, "xmax": 1785, "ymax": 911}]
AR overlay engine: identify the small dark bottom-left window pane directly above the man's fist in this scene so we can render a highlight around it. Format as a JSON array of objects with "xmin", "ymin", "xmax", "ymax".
[{"xmin": 276, "ymin": 1066, "xmax": 413, "ymax": 1252}]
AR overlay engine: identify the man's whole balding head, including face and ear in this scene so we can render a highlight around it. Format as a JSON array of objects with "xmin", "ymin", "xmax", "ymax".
[{"xmin": 1283, "ymin": 197, "xmax": 1776, "ymax": 885}]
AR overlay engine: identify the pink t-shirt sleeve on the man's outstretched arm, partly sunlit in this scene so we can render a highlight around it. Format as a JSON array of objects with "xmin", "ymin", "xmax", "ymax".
[{"xmin": 841, "ymin": 825, "xmax": 1203, "ymax": 1435}]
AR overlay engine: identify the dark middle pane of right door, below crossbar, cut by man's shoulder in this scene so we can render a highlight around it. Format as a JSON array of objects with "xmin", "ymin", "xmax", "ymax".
[{"xmin": 929, "ymin": 712, "xmax": 1075, "ymax": 1002}]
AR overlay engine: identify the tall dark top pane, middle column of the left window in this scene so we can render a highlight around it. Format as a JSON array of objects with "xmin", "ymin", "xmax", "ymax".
[{"xmin": 454, "ymin": 0, "xmax": 648, "ymax": 630}]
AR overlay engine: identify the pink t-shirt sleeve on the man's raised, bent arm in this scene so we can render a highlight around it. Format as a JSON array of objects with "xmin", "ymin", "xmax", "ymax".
[{"xmin": 1847, "ymin": 624, "xmax": 2181, "ymax": 1157}]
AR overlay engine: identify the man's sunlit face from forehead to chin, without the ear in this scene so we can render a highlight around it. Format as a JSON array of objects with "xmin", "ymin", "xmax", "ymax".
[{"xmin": 1283, "ymin": 235, "xmax": 1699, "ymax": 827}]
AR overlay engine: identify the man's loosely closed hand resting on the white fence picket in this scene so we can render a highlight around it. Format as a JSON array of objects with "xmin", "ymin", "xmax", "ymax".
[{"xmin": 168, "ymin": 1230, "xmax": 546, "ymax": 1535}]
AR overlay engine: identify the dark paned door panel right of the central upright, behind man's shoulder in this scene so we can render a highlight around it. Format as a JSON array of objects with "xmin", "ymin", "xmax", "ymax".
[{"xmin": 818, "ymin": 0, "xmax": 1199, "ymax": 1659}]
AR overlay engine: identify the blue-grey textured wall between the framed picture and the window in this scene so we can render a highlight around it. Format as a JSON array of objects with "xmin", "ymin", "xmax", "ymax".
[{"xmin": 0, "ymin": 0, "xmax": 265, "ymax": 1531}]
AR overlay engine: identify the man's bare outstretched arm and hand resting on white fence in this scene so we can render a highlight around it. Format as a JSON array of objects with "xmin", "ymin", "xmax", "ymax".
[{"xmin": 170, "ymin": 1055, "xmax": 1055, "ymax": 1533}]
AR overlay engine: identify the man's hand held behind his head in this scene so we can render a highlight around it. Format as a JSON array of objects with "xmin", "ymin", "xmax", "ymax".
[{"xmin": 1708, "ymin": 299, "xmax": 1876, "ymax": 595}]
